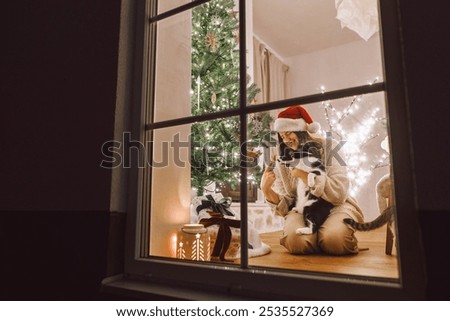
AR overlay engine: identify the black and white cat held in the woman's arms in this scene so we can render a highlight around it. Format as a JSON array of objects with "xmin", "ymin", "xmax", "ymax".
[{"xmin": 281, "ymin": 141, "xmax": 334, "ymax": 235}]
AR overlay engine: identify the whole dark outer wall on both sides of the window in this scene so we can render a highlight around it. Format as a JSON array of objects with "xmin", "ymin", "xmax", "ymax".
[{"xmin": 0, "ymin": 0, "xmax": 450, "ymax": 300}]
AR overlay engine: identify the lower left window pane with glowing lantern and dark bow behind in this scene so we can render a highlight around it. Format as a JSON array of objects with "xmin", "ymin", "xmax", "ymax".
[{"xmin": 150, "ymin": 118, "xmax": 240, "ymax": 263}]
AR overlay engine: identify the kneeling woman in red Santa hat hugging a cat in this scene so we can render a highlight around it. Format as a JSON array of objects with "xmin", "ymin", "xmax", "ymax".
[{"xmin": 261, "ymin": 106, "xmax": 364, "ymax": 255}]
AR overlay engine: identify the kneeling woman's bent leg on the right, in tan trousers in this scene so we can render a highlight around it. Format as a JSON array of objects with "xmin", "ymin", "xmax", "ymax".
[{"xmin": 317, "ymin": 208, "xmax": 358, "ymax": 255}]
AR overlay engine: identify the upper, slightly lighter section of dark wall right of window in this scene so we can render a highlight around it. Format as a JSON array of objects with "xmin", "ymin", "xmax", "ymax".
[{"xmin": 400, "ymin": 0, "xmax": 450, "ymax": 211}]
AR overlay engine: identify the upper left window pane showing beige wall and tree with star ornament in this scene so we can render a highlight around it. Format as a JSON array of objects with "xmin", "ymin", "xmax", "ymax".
[{"xmin": 154, "ymin": 0, "xmax": 239, "ymax": 121}]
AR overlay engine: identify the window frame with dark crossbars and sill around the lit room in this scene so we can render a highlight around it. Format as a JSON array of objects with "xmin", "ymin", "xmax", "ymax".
[{"xmin": 103, "ymin": 0, "xmax": 425, "ymax": 300}]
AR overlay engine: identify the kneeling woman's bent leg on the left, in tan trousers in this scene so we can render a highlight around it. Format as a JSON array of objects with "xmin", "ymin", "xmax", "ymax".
[{"xmin": 280, "ymin": 211, "xmax": 320, "ymax": 254}]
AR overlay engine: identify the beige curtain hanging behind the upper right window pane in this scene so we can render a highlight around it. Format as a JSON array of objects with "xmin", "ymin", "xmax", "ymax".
[{"xmin": 253, "ymin": 38, "xmax": 289, "ymax": 103}]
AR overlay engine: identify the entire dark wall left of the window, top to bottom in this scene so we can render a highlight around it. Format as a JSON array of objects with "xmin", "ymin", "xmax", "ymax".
[{"xmin": 0, "ymin": 0, "xmax": 120, "ymax": 299}]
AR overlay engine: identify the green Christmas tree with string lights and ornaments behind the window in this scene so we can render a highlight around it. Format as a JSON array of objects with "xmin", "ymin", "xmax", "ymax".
[{"xmin": 191, "ymin": 0, "xmax": 271, "ymax": 195}]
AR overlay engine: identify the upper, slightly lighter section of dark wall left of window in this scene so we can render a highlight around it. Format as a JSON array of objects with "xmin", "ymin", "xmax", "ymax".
[{"xmin": 0, "ymin": 0, "xmax": 120, "ymax": 211}]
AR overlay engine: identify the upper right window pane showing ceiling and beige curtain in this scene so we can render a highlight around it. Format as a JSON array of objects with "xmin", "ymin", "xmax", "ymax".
[{"xmin": 247, "ymin": 0, "xmax": 383, "ymax": 103}]
